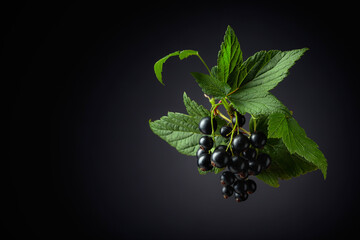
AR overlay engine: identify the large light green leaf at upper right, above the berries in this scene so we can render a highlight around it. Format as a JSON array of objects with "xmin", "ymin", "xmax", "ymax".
[{"xmin": 228, "ymin": 48, "xmax": 307, "ymax": 116}]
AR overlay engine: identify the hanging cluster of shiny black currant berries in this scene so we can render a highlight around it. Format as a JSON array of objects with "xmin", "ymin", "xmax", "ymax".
[{"xmin": 196, "ymin": 112, "xmax": 271, "ymax": 202}]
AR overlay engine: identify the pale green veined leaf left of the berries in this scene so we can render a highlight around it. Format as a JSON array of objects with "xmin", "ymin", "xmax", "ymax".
[{"xmin": 149, "ymin": 112, "xmax": 224, "ymax": 156}]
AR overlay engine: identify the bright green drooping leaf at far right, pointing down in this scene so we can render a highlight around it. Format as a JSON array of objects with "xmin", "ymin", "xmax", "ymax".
[{"xmin": 268, "ymin": 113, "xmax": 327, "ymax": 178}]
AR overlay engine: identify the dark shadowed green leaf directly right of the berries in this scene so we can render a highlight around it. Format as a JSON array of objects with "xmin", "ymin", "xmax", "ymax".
[{"xmin": 257, "ymin": 139, "xmax": 317, "ymax": 187}]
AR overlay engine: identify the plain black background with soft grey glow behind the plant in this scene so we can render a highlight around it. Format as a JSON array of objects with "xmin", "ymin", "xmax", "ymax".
[{"xmin": 1, "ymin": 1, "xmax": 360, "ymax": 239}]
